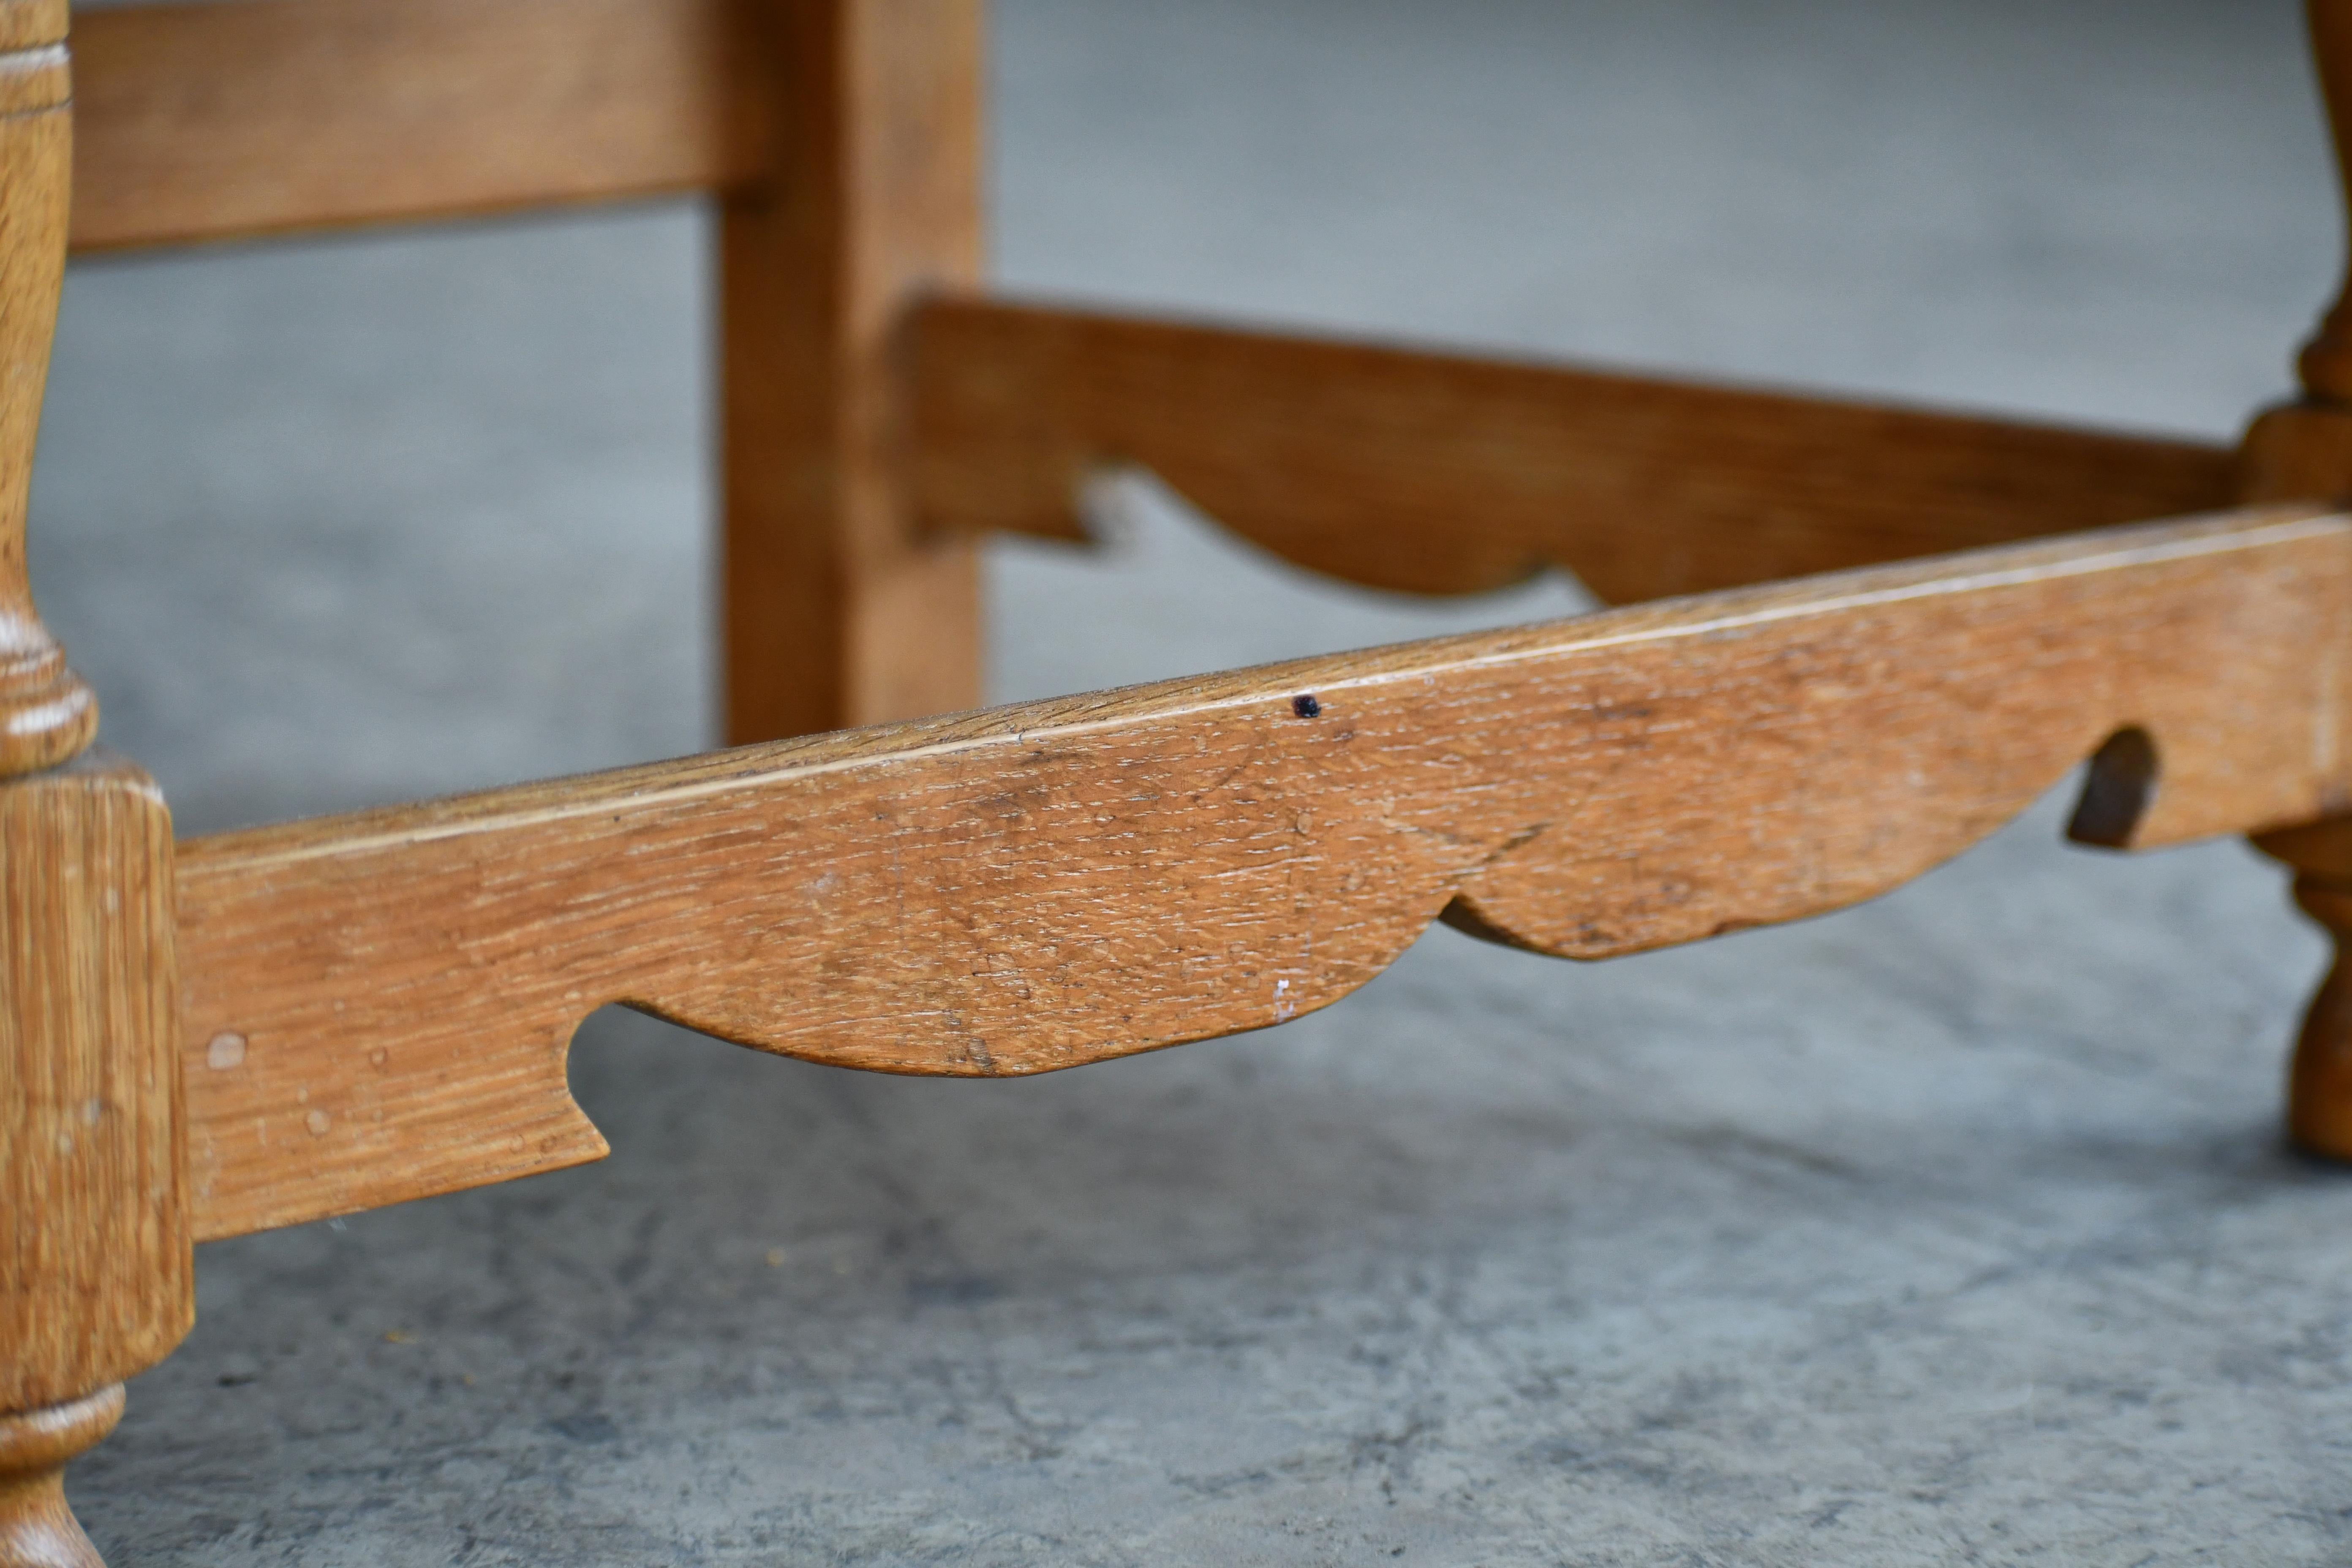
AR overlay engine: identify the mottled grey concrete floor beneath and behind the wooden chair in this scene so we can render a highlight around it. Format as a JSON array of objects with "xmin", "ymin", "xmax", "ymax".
[{"xmin": 33, "ymin": 0, "xmax": 2352, "ymax": 1565}]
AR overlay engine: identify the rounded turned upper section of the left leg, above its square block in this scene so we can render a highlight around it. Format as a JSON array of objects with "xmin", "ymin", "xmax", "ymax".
[{"xmin": 0, "ymin": 20, "xmax": 99, "ymax": 776}]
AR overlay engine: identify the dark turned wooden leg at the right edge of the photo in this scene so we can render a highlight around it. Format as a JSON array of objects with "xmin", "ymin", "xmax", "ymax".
[{"xmin": 2239, "ymin": 0, "xmax": 2352, "ymax": 1159}]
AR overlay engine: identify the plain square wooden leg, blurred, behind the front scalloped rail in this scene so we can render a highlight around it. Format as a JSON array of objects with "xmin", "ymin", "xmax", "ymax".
[{"xmin": 720, "ymin": 0, "xmax": 981, "ymax": 743}]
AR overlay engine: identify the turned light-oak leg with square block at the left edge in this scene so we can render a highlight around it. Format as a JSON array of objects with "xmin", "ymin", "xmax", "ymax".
[{"xmin": 0, "ymin": 0, "xmax": 195, "ymax": 1568}]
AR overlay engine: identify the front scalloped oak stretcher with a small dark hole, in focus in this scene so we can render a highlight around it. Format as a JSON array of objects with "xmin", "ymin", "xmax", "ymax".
[{"xmin": 179, "ymin": 510, "xmax": 2352, "ymax": 1236}]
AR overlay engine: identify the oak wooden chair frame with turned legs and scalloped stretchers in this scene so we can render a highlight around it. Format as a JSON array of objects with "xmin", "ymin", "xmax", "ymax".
[{"xmin": 14, "ymin": 0, "xmax": 2352, "ymax": 1563}]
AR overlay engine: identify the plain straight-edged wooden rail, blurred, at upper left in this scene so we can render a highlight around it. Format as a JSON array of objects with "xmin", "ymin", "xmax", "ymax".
[{"xmin": 73, "ymin": 0, "xmax": 769, "ymax": 249}]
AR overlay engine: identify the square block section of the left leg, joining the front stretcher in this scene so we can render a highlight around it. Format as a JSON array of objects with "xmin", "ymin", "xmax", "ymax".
[{"xmin": 0, "ymin": 752, "xmax": 195, "ymax": 1410}]
